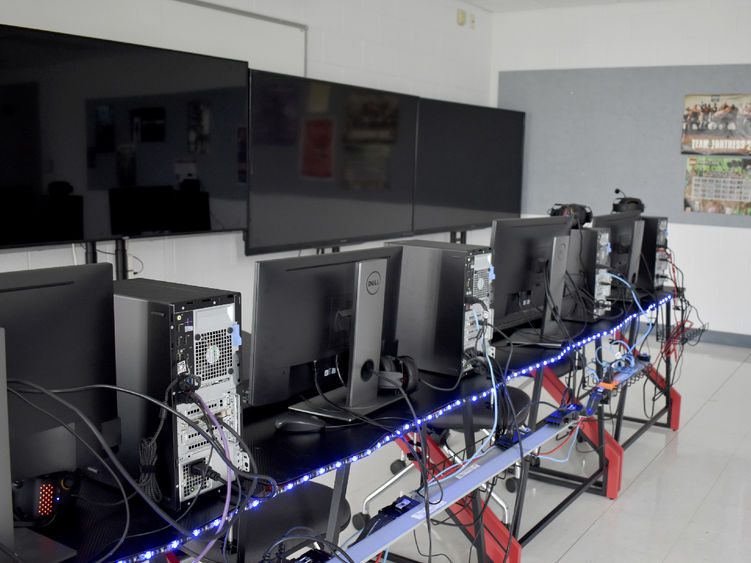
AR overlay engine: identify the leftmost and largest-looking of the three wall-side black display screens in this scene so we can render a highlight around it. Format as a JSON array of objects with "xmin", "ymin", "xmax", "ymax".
[{"xmin": 0, "ymin": 26, "xmax": 248, "ymax": 247}]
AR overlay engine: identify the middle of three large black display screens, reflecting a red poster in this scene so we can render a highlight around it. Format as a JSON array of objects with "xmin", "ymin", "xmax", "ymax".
[{"xmin": 246, "ymin": 71, "xmax": 417, "ymax": 254}]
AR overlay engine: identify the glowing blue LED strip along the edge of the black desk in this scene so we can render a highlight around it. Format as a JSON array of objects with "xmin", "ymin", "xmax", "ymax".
[{"xmin": 123, "ymin": 295, "xmax": 673, "ymax": 563}]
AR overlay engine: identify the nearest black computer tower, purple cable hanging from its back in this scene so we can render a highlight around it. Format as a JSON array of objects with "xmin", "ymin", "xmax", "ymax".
[{"xmin": 114, "ymin": 279, "xmax": 248, "ymax": 509}]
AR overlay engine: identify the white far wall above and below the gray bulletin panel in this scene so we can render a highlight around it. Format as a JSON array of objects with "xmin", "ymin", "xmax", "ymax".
[{"xmin": 490, "ymin": 0, "xmax": 751, "ymax": 335}]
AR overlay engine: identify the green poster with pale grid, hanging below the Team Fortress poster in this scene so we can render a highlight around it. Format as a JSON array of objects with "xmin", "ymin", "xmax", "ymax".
[{"xmin": 683, "ymin": 156, "xmax": 751, "ymax": 215}]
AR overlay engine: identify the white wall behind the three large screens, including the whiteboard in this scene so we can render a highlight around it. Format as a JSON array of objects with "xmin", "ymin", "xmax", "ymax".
[{"xmin": 0, "ymin": 0, "xmax": 495, "ymax": 327}]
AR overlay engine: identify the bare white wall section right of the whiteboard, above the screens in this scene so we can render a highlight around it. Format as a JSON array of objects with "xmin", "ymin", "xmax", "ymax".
[{"xmin": 262, "ymin": 0, "xmax": 495, "ymax": 105}]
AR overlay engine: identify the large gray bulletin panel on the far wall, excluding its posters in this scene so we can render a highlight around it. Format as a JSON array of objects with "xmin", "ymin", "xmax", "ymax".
[{"xmin": 498, "ymin": 65, "xmax": 751, "ymax": 227}]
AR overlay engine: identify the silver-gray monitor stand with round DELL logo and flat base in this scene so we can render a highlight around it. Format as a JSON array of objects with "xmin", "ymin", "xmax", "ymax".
[{"xmin": 289, "ymin": 258, "xmax": 402, "ymax": 422}]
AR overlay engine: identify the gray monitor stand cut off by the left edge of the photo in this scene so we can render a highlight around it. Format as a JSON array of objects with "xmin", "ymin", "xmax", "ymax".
[{"xmin": 0, "ymin": 328, "xmax": 76, "ymax": 563}]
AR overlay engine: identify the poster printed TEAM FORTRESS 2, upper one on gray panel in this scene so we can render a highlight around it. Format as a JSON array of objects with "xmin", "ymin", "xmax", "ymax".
[{"xmin": 681, "ymin": 94, "xmax": 751, "ymax": 155}]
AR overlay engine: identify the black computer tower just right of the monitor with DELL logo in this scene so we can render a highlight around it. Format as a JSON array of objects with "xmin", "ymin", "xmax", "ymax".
[{"xmin": 389, "ymin": 241, "xmax": 495, "ymax": 376}]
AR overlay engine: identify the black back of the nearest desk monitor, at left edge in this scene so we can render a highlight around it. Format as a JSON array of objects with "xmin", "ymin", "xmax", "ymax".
[{"xmin": 0, "ymin": 264, "xmax": 120, "ymax": 480}]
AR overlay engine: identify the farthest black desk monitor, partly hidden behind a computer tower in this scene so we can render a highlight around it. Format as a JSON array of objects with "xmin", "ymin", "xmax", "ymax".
[{"xmin": 592, "ymin": 210, "xmax": 644, "ymax": 299}]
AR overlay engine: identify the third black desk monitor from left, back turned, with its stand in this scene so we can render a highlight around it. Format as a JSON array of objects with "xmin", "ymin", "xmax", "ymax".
[{"xmin": 491, "ymin": 216, "xmax": 572, "ymax": 341}]
